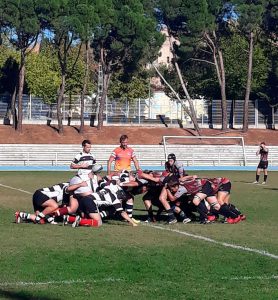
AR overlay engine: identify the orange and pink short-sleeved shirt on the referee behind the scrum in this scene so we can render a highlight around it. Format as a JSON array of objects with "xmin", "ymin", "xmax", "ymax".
[{"xmin": 111, "ymin": 147, "xmax": 135, "ymax": 172}]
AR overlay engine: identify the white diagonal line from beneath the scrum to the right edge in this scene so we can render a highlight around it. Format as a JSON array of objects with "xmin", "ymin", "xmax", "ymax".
[{"xmin": 147, "ymin": 224, "xmax": 278, "ymax": 259}]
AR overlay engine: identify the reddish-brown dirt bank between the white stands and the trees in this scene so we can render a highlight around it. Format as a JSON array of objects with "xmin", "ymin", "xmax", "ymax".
[{"xmin": 0, "ymin": 125, "xmax": 278, "ymax": 145}]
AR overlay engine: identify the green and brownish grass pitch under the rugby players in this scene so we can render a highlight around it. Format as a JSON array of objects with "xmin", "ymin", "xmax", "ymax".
[{"xmin": 0, "ymin": 171, "xmax": 278, "ymax": 300}]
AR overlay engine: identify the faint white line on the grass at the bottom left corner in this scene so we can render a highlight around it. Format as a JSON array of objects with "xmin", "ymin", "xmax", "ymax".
[{"xmin": 0, "ymin": 278, "xmax": 123, "ymax": 287}]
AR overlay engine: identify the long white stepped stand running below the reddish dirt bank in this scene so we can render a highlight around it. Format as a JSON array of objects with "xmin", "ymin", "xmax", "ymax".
[{"xmin": 0, "ymin": 144, "xmax": 278, "ymax": 167}]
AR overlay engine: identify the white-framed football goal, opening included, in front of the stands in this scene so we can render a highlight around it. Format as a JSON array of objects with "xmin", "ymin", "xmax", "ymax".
[{"xmin": 163, "ymin": 135, "xmax": 247, "ymax": 166}]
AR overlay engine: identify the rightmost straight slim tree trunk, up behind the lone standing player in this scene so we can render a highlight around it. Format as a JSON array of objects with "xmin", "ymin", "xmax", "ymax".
[{"xmin": 242, "ymin": 32, "xmax": 254, "ymax": 132}]
